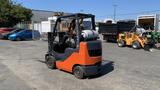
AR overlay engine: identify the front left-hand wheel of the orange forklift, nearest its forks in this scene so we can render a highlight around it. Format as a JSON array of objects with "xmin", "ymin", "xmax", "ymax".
[{"xmin": 45, "ymin": 55, "xmax": 56, "ymax": 69}]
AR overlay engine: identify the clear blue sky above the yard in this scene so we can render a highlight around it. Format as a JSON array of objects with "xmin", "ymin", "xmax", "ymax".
[{"xmin": 14, "ymin": 0, "xmax": 160, "ymax": 20}]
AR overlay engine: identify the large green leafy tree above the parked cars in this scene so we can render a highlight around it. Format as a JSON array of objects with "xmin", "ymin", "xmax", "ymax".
[{"xmin": 0, "ymin": 0, "xmax": 32, "ymax": 27}]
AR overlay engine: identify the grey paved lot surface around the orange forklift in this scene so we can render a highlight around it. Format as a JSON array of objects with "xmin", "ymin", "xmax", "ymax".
[{"xmin": 0, "ymin": 40, "xmax": 160, "ymax": 90}]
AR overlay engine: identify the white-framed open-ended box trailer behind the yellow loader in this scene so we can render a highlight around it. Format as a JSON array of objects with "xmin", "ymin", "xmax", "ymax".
[{"xmin": 137, "ymin": 14, "xmax": 160, "ymax": 31}]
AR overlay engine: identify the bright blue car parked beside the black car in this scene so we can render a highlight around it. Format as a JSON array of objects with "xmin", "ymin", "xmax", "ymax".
[{"xmin": 8, "ymin": 30, "xmax": 40, "ymax": 41}]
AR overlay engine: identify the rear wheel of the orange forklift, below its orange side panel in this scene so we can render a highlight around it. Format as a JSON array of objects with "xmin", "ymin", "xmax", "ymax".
[{"xmin": 73, "ymin": 66, "xmax": 84, "ymax": 79}]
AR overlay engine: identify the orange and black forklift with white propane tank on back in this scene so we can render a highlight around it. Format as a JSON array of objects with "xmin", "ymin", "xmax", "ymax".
[{"xmin": 45, "ymin": 13, "xmax": 102, "ymax": 79}]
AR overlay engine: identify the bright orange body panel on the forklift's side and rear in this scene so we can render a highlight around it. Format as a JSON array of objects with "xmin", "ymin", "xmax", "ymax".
[{"xmin": 56, "ymin": 42, "xmax": 102, "ymax": 73}]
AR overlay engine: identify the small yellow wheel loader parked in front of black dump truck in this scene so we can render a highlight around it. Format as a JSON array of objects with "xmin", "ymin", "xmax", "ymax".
[{"xmin": 117, "ymin": 32, "xmax": 154, "ymax": 51}]
